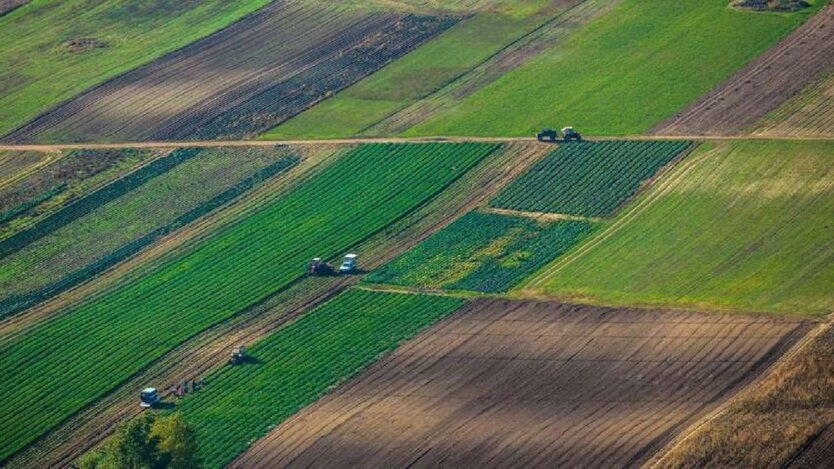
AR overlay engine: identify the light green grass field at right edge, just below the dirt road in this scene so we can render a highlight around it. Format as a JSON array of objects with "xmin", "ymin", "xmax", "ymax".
[{"xmin": 527, "ymin": 141, "xmax": 834, "ymax": 314}]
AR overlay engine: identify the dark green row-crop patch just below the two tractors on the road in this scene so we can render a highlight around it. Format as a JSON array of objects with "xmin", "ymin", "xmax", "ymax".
[{"xmin": 490, "ymin": 140, "xmax": 692, "ymax": 217}]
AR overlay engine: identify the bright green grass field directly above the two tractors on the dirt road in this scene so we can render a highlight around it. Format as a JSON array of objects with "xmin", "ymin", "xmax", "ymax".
[{"xmin": 404, "ymin": 0, "xmax": 820, "ymax": 136}]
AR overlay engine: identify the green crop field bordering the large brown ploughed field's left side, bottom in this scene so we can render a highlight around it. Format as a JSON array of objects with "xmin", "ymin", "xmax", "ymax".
[{"xmin": 178, "ymin": 290, "xmax": 464, "ymax": 468}]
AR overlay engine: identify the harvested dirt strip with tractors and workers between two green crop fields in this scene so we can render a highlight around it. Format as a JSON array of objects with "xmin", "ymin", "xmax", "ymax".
[{"xmin": 0, "ymin": 144, "xmax": 545, "ymax": 467}]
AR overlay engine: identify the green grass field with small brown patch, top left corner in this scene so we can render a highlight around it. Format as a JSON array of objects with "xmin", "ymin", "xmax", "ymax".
[{"xmin": 0, "ymin": 0, "xmax": 269, "ymax": 135}]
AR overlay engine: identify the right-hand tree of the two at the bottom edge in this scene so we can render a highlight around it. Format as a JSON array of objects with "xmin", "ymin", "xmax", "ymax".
[{"xmin": 151, "ymin": 413, "xmax": 201, "ymax": 469}]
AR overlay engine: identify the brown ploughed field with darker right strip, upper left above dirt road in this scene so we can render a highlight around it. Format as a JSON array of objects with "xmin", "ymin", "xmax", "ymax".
[{"xmin": 6, "ymin": 1, "xmax": 457, "ymax": 142}]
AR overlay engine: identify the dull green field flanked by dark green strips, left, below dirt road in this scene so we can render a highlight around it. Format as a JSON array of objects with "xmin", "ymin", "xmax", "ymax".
[{"xmin": 0, "ymin": 147, "xmax": 298, "ymax": 317}]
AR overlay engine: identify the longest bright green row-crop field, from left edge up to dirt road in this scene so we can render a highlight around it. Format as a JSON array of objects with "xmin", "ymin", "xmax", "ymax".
[{"xmin": 0, "ymin": 143, "xmax": 498, "ymax": 460}]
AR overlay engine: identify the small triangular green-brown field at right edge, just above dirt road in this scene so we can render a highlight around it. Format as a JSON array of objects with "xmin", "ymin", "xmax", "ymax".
[{"xmin": 753, "ymin": 68, "xmax": 834, "ymax": 137}]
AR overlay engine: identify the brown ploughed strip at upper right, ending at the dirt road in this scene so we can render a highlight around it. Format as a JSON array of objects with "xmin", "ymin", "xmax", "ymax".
[{"xmin": 653, "ymin": 4, "xmax": 834, "ymax": 135}]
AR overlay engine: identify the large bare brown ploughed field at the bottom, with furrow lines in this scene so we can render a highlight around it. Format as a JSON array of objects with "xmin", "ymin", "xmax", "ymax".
[{"xmin": 232, "ymin": 299, "xmax": 810, "ymax": 467}]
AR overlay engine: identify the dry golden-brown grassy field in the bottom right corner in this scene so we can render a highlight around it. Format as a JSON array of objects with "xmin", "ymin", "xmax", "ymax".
[{"xmin": 655, "ymin": 322, "xmax": 834, "ymax": 469}]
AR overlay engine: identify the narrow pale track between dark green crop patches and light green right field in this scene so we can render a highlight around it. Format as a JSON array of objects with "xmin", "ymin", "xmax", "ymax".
[{"xmin": 517, "ymin": 145, "xmax": 723, "ymax": 294}]
